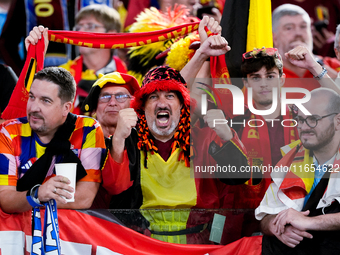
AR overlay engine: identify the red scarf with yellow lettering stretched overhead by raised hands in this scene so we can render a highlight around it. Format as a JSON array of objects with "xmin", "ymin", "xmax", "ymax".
[{"xmin": 2, "ymin": 22, "xmax": 199, "ymax": 119}]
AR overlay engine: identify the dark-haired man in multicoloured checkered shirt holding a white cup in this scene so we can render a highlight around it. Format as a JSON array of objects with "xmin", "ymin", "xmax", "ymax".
[{"xmin": 0, "ymin": 67, "xmax": 105, "ymax": 213}]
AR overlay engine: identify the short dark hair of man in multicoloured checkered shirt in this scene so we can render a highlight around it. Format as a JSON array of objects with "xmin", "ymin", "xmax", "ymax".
[{"xmin": 33, "ymin": 67, "xmax": 76, "ymax": 103}]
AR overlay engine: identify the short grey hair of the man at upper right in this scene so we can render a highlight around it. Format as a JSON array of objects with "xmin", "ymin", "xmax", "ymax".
[{"xmin": 272, "ymin": 4, "xmax": 311, "ymax": 33}]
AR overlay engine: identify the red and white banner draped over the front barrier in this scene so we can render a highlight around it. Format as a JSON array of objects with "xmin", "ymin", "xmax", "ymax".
[{"xmin": 0, "ymin": 209, "xmax": 262, "ymax": 255}]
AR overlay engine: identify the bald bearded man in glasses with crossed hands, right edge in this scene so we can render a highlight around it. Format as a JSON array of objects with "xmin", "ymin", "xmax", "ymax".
[{"xmin": 255, "ymin": 88, "xmax": 340, "ymax": 254}]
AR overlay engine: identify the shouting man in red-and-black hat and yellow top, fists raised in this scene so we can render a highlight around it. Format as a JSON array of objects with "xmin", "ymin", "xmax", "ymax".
[{"xmin": 98, "ymin": 16, "xmax": 248, "ymax": 243}]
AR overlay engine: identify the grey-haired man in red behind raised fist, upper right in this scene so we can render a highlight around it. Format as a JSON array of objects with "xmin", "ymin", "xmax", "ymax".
[{"xmin": 272, "ymin": 4, "xmax": 340, "ymax": 98}]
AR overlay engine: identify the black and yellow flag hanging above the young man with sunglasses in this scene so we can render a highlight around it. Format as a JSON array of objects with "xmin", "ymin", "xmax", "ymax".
[{"xmin": 211, "ymin": 0, "xmax": 273, "ymax": 81}]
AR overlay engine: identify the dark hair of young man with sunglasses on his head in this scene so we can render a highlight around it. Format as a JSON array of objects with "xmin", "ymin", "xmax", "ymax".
[{"xmin": 241, "ymin": 56, "xmax": 283, "ymax": 78}]
